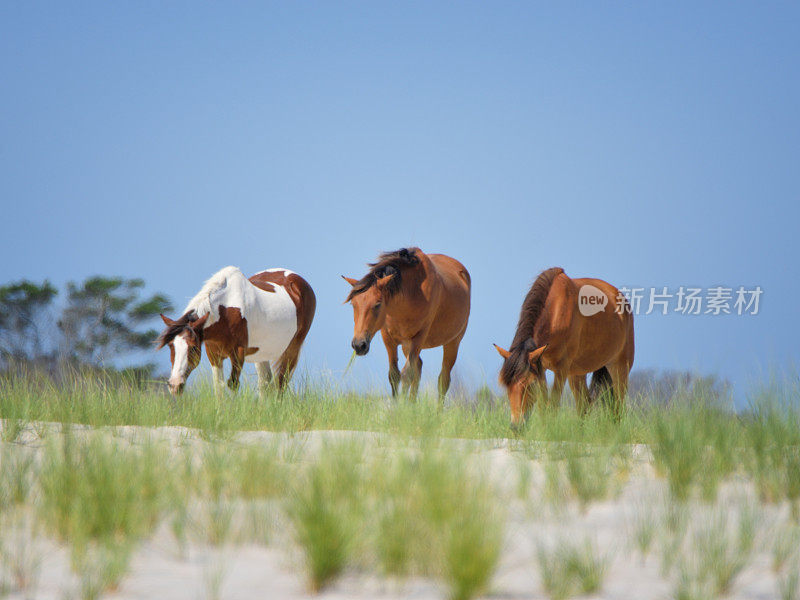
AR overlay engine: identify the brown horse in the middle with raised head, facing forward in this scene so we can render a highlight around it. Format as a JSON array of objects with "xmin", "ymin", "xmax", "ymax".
[{"xmin": 342, "ymin": 248, "xmax": 471, "ymax": 399}]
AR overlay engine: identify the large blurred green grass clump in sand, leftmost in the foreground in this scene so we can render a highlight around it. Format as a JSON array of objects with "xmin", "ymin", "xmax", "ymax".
[{"xmin": 39, "ymin": 430, "xmax": 171, "ymax": 598}]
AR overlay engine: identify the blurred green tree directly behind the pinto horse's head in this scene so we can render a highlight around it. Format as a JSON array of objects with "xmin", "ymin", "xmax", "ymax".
[{"xmin": 58, "ymin": 276, "xmax": 172, "ymax": 367}]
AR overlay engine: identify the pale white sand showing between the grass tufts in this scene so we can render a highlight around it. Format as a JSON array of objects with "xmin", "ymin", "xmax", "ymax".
[{"xmin": 0, "ymin": 426, "xmax": 787, "ymax": 600}]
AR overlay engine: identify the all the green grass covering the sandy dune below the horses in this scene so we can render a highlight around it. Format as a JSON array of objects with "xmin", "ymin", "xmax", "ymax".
[{"xmin": 0, "ymin": 378, "xmax": 800, "ymax": 600}]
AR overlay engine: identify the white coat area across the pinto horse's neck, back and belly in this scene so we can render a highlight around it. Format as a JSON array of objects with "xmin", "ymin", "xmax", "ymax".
[{"xmin": 184, "ymin": 267, "xmax": 297, "ymax": 362}]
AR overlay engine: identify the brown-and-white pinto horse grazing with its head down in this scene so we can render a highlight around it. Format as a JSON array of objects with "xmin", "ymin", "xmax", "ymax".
[{"xmin": 157, "ymin": 267, "xmax": 317, "ymax": 395}]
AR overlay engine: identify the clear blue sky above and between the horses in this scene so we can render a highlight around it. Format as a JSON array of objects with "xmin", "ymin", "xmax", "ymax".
[{"xmin": 0, "ymin": 1, "xmax": 800, "ymax": 404}]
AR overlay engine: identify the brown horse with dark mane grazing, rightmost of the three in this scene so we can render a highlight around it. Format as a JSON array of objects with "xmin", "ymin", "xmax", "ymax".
[{"xmin": 495, "ymin": 267, "xmax": 633, "ymax": 425}]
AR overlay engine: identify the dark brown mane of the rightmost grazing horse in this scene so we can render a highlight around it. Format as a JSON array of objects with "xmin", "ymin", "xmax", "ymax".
[{"xmin": 500, "ymin": 267, "xmax": 564, "ymax": 386}]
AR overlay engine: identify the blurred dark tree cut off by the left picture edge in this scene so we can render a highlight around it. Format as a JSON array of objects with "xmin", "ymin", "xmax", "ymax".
[{"xmin": 0, "ymin": 279, "xmax": 58, "ymax": 363}]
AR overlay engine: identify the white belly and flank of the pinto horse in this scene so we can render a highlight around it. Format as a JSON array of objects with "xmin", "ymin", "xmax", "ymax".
[{"xmin": 245, "ymin": 285, "xmax": 297, "ymax": 362}]
